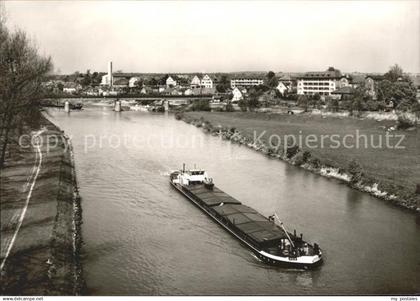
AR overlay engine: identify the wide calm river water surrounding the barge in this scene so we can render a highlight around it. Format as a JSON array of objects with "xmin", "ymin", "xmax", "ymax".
[{"xmin": 50, "ymin": 107, "xmax": 420, "ymax": 295}]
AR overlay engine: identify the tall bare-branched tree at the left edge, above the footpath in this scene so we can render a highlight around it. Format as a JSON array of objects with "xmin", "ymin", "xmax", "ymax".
[{"xmin": 0, "ymin": 18, "xmax": 52, "ymax": 167}]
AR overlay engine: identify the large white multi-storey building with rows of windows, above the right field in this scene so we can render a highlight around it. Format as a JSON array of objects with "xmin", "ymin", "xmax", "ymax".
[{"xmin": 297, "ymin": 70, "xmax": 342, "ymax": 95}]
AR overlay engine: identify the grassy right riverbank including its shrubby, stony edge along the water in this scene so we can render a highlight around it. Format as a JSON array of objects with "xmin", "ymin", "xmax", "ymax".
[{"xmin": 182, "ymin": 112, "xmax": 420, "ymax": 210}]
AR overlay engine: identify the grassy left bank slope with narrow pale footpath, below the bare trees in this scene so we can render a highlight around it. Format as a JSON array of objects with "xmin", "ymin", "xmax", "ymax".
[{"xmin": 0, "ymin": 118, "xmax": 84, "ymax": 295}]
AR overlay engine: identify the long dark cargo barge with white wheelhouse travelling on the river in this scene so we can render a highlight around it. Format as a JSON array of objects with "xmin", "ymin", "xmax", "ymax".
[{"xmin": 170, "ymin": 166, "xmax": 322, "ymax": 269}]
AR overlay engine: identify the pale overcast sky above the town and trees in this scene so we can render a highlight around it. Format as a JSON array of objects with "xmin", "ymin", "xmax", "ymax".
[{"xmin": 5, "ymin": 0, "xmax": 420, "ymax": 74}]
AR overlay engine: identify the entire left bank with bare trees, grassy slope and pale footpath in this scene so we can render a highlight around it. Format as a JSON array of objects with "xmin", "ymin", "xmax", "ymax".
[{"xmin": 0, "ymin": 14, "xmax": 85, "ymax": 296}]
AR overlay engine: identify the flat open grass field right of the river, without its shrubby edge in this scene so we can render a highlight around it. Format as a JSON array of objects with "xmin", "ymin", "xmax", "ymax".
[{"xmin": 185, "ymin": 112, "xmax": 420, "ymax": 210}]
